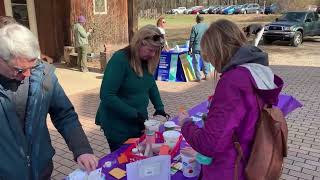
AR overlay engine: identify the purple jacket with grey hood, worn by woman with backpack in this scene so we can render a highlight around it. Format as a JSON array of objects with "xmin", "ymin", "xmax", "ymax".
[{"xmin": 182, "ymin": 46, "xmax": 283, "ymax": 180}]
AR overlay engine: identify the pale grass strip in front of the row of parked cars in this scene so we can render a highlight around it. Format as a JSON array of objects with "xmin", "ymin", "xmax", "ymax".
[{"xmin": 139, "ymin": 14, "xmax": 280, "ymax": 47}]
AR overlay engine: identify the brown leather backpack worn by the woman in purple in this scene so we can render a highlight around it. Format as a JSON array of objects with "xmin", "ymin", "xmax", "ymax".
[{"xmin": 233, "ymin": 98, "xmax": 288, "ymax": 180}]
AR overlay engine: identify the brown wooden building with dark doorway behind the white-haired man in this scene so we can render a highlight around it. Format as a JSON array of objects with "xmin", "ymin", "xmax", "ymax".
[{"xmin": 0, "ymin": 0, "xmax": 138, "ymax": 61}]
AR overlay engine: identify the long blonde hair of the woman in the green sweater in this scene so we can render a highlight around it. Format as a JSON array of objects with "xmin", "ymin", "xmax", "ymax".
[{"xmin": 129, "ymin": 25, "xmax": 164, "ymax": 77}]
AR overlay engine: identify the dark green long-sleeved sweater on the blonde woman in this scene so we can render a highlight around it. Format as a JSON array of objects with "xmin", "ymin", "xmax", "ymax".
[{"xmin": 96, "ymin": 50, "xmax": 163, "ymax": 143}]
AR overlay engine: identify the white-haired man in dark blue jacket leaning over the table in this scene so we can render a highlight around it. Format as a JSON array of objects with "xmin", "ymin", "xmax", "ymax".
[{"xmin": 0, "ymin": 23, "xmax": 97, "ymax": 180}]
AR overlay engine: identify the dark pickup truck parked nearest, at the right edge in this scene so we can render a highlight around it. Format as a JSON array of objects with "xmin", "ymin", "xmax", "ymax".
[{"xmin": 263, "ymin": 11, "xmax": 320, "ymax": 47}]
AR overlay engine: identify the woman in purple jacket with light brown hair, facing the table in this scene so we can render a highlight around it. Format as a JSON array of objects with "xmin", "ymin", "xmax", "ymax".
[{"xmin": 180, "ymin": 20, "xmax": 283, "ymax": 180}]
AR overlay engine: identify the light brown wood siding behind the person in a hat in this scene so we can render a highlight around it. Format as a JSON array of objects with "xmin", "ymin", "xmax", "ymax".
[{"xmin": 70, "ymin": 0, "xmax": 129, "ymax": 52}]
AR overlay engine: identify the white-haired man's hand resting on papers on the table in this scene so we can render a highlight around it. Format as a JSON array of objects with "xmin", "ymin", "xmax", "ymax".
[{"xmin": 77, "ymin": 154, "xmax": 98, "ymax": 172}]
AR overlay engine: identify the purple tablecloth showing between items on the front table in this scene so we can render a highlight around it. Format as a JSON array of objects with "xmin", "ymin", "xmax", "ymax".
[{"xmin": 98, "ymin": 95, "xmax": 302, "ymax": 180}]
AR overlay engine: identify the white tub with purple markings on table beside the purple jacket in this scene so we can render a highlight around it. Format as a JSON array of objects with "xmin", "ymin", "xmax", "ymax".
[{"xmin": 181, "ymin": 153, "xmax": 201, "ymax": 178}]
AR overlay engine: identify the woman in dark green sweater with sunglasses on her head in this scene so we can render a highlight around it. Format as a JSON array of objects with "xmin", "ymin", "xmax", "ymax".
[{"xmin": 96, "ymin": 25, "xmax": 168, "ymax": 152}]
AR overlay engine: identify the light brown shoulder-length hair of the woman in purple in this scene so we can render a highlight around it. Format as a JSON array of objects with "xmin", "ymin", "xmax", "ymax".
[{"xmin": 200, "ymin": 19, "xmax": 247, "ymax": 72}]
